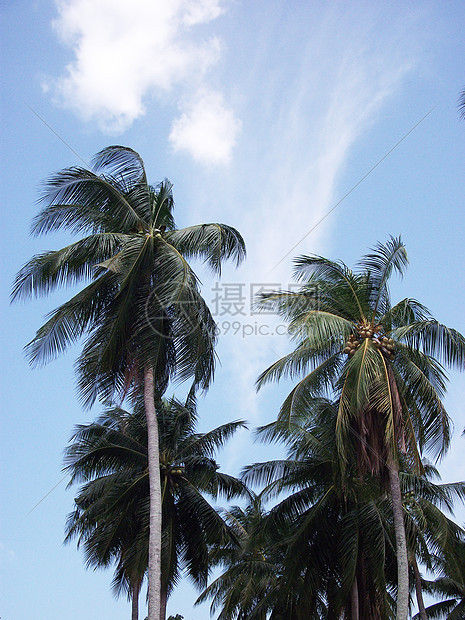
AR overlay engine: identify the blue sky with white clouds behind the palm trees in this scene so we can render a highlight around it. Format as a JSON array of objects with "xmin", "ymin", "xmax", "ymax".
[{"xmin": 0, "ymin": 0, "xmax": 465, "ymax": 620}]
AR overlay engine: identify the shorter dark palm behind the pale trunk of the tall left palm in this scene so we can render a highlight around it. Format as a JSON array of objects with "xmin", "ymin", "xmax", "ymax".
[{"xmin": 65, "ymin": 399, "xmax": 245, "ymax": 620}]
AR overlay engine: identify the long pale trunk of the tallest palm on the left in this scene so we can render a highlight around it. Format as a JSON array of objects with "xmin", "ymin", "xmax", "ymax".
[{"xmin": 144, "ymin": 368, "xmax": 161, "ymax": 620}]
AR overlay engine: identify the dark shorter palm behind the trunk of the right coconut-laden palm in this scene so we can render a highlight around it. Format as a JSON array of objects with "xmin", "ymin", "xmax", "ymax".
[{"xmin": 241, "ymin": 399, "xmax": 465, "ymax": 620}]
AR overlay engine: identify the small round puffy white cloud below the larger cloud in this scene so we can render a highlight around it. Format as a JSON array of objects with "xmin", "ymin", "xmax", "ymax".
[{"xmin": 169, "ymin": 91, "xmax": 241, "ymax": 164}]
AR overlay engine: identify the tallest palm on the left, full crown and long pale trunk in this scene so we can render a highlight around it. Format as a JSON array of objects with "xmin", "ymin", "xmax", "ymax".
[{"xmin": 12, "ymin": 146, "xmax": 245, "ymax": 620}]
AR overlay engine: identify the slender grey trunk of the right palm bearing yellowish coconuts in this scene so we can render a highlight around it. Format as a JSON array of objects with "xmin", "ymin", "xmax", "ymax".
[{"xmin": 388, "ymin": 454, "xmax": 409, "ymax": 620}]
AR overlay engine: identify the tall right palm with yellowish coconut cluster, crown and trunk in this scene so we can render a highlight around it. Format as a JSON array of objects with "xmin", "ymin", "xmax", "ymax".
[{"xmin": 258, "ymin": 238, "xmax": 465, "ymax": 620}]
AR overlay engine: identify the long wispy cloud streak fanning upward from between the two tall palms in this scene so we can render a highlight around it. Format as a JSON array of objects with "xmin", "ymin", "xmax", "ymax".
[{"xmin": 190, "ymin": 3, "xmax": 422, "ymax": 464}]
